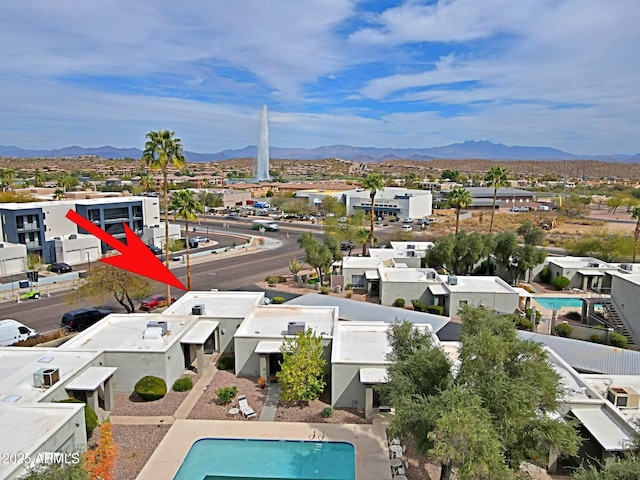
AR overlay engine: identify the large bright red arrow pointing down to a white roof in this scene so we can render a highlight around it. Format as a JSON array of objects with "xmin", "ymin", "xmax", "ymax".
[{"xmin": 66, "ymin": 210, "xmax": 186, "ymax": 290}]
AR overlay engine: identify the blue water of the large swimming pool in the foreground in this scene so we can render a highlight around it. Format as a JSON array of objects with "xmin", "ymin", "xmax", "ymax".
[{"xmin": 174, "ymin": 438, "xmax": 356, "ymax": 480}]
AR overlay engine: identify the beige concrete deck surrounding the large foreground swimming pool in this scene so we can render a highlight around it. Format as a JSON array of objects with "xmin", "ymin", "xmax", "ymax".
[{"xmin": 137, "ymin": 415, "xmax": 391, "ymax": 480}]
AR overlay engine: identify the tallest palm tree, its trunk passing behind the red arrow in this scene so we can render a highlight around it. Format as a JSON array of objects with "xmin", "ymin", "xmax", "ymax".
[{"xmin": 142, "ymin": 130, "xmax": 185, "ymax": 305}]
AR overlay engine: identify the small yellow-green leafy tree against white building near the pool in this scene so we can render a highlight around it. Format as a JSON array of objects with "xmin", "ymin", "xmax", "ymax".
[{"xmin": 278, "ymin": 329, "xmax": 327, "ymax": 402}]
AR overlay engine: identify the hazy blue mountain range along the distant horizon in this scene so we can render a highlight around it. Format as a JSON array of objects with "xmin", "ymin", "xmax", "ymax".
[{"xmin": 0, "ymin": 140, "xmax": 640, "ymax": 163}]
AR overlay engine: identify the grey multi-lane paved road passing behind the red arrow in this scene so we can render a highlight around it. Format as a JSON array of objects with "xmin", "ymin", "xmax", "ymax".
[{"xmin": 0, "ymin": 227, "xmax": 302, "ymax": 332}]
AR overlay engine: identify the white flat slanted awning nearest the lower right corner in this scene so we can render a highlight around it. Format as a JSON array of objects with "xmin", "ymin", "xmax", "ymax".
[{"xmin": 571, "ymin": 405, "xmax": 633, "ymax": 451}]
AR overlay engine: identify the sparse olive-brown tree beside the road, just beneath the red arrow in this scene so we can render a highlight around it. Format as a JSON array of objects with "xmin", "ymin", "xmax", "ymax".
[{"xmin": 68, "ymin": 263, "xmax": 152, "ymax": 313}]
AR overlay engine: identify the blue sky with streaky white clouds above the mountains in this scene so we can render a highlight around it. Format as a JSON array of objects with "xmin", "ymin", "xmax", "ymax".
[{"xmin": 0, "ymin": 0, "xmax": 640, "ymax": 154}]
